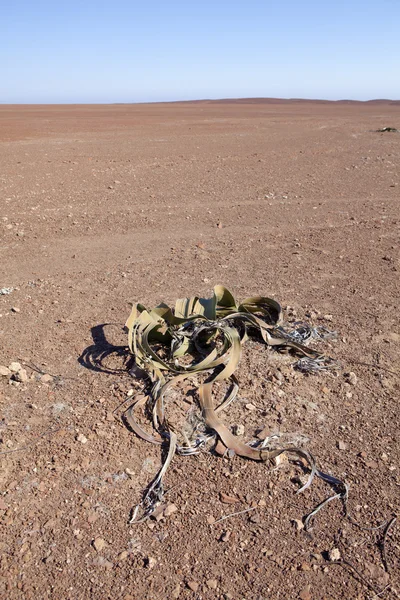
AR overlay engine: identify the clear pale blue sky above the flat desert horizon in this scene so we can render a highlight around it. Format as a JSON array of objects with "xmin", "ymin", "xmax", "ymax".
[{"xmin": 0, "ymin": 0, "xmax": 400, "ymax": 103}]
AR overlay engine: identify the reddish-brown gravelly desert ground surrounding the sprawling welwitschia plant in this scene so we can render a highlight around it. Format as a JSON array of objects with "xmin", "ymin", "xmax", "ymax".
[{"xmin": 0, "ymin": 101, "xmax": 400, "ymax": 600}]
